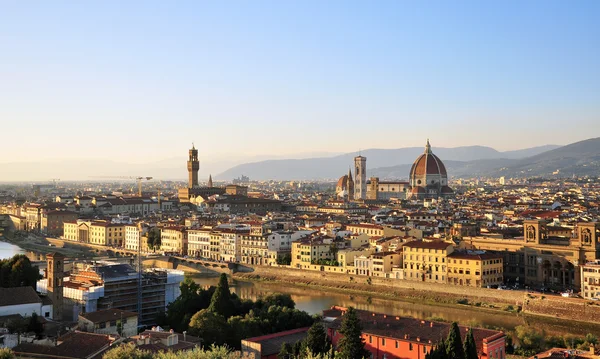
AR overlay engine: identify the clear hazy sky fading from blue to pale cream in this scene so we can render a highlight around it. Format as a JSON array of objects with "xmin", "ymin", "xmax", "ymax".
[{"xmin": 0, "ymin": 0, "xmax": 600, "ymax": 162}]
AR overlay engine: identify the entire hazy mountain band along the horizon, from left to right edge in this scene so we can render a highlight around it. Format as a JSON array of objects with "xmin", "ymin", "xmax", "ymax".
[{"xmin": 0, "ymin": 138, "xmax": 600, "ymax": 183}]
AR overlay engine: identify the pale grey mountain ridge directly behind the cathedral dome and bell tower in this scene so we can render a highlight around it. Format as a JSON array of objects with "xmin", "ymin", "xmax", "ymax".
[{"xmin": 215, "ymin": 145, "xmax": 572, "ymax": 180}]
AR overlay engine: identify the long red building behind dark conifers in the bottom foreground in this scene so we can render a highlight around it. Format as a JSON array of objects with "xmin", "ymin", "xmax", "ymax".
[{"xmin": 323, "ymin": 306, "xmax": 506, "ymax": 359}]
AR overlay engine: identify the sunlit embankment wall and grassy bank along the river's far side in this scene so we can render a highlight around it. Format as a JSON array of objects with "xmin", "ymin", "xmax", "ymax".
[{"xmin": 233, "ymin": 266, "xmax": 600, "ymax": 329}]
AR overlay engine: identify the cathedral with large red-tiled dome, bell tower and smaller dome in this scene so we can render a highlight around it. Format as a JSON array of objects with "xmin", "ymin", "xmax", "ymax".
[{"xmin": 336, "ymin": 140, "xmax": 454, "ymax": 201}]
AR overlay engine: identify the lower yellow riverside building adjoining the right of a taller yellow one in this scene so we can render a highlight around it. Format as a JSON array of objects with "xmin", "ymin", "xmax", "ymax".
[{"xmin": 447, "ymin": 251, "xmax": 504, "ymax": 287}]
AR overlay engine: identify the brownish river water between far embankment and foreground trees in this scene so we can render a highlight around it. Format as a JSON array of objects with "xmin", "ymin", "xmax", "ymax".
[{"xmin": 194, "ymin": 277, "xmax": 600, "ymax": 335}]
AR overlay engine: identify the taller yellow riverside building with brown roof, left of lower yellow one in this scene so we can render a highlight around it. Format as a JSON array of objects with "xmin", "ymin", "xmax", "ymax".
[{"xmin": 402, "ymin": 240, "xmax": 454, "ymax": 283}]
